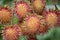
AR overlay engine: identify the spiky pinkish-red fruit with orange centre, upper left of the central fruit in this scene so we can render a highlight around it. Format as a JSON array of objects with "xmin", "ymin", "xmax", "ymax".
[{"xmin": 15, "ymin": 1, "xmax": 30, "ymax": 19}]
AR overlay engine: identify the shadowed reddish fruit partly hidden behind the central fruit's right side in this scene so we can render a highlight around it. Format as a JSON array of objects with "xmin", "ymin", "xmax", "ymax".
[{"xmin": 38, "ymin": 16, "xmax": 49, "ymax": 34}]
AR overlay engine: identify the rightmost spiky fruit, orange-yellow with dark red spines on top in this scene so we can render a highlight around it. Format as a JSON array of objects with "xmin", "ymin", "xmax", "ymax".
[{"xmin": 43, "ymin": 9, "xmax": 58, "ymax": 26}]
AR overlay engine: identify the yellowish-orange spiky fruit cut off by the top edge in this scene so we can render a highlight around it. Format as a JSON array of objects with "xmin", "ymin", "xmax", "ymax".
[{"xmin": 31, "ymin": 0, "xmax": 45, "ymax": 14}]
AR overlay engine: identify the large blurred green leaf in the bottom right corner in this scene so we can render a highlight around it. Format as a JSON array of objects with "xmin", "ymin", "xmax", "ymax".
[{"xmin": 37, "ymin": 27, "xmax": 60, "ymax": 40}]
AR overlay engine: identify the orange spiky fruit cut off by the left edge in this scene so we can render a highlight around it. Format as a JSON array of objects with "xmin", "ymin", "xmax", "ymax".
[{"xmin": 0, "ymin": 7, "xmax": 12, "ymax": 24}]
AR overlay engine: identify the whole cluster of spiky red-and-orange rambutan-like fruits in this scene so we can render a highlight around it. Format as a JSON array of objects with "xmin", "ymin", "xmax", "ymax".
[{"xmin": 0, "ymin": 0, "xmax": 60, "ymax": 40}]
